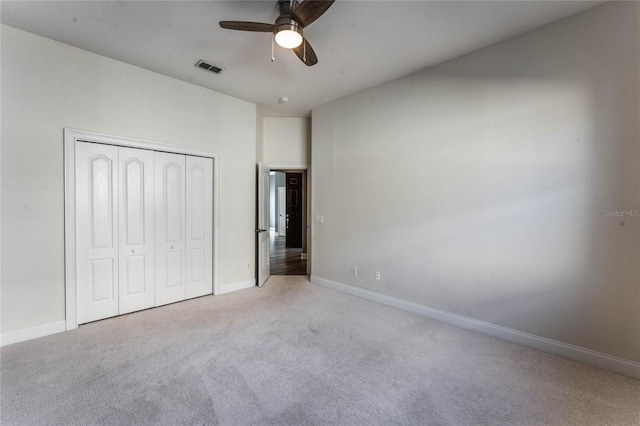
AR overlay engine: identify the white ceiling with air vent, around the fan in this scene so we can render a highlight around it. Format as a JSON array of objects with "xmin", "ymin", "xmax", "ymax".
[{"xmin": 0, "ymin": 0, "xmax": 603, "ymax": 117}]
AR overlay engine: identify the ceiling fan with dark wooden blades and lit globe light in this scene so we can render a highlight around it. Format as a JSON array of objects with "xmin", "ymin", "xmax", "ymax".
[{"xmin": 220, "ymin": 0, "xmax": 335, "ymax": 66}]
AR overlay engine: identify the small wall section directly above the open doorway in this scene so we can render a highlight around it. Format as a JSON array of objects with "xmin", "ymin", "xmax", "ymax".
[{"xmin": 263, "ymin": 117, "xmax": 311, "ymax": 166}]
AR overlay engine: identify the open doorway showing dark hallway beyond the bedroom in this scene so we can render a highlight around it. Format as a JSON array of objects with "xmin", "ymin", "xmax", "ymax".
[{"xmin": 269, "ymin": 170, "xmax": 307, "ymax": 275}]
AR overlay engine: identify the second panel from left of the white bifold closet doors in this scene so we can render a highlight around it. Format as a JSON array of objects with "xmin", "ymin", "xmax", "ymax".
[{"xmin": 118, "ymin": 148, "xmax": 155, "ymax": 314}]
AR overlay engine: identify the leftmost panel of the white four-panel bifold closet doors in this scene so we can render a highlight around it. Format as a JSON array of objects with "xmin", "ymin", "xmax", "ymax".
[{"xmin": 76, "ymin": 142, "xmax": 119, "ymax": 324}]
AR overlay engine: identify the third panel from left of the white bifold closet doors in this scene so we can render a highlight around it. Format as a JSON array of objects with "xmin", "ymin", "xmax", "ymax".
[{"xmin": 155, "ymin": 152, "xmax": 186, "ymax": 306}]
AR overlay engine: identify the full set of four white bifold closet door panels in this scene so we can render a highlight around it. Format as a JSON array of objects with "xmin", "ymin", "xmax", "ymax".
[{"xmin": 75, "ymin": 142, "xmax": 213, "ymax": 324}]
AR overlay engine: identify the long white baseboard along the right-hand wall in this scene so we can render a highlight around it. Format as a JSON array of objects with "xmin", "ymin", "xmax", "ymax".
[{"xmin": 310, "ymin": 275, "xmax": 640, "ymax": 379}]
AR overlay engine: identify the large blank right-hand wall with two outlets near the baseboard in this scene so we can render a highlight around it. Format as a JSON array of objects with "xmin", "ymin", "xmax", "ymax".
[{"xmin": 312, "ymin": 2, "xmax": 640, "ymax": 362}]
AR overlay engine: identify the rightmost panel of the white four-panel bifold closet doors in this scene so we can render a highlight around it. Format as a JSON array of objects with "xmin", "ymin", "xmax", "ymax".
[{"xmin": 185, "ymin": 156, "xmax": 213, "ymax": 299}]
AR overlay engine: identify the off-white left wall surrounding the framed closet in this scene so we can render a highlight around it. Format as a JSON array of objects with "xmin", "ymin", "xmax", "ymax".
[{"xmin": 1, "ymin": 25, "xmax": 257, "ymax": 333}]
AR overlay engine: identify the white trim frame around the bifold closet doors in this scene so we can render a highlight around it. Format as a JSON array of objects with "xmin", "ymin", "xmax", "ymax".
[{"xmin": 64, "ymin": 128, "xmax": 220, "ymax": 331}]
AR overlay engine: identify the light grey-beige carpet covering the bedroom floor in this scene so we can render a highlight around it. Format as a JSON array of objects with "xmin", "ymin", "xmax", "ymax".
[{"xmin": 0, "ymin": 276, "xmax": 640, "ymax": 425}]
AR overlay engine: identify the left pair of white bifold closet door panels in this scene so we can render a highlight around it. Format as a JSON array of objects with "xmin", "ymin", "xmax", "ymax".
[{"xmin": 76, "ymin": 142, "xmax": 155, "ymax": 323}]
